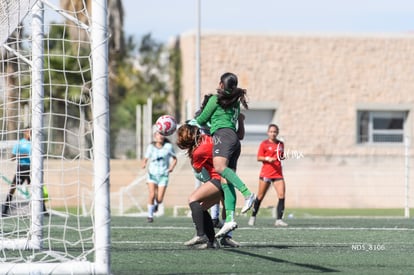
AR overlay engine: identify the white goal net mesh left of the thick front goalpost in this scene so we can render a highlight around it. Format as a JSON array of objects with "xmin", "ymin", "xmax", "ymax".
[{"xmin": 0, "ymin": 0, "xmax": 100, "ymax": 268}]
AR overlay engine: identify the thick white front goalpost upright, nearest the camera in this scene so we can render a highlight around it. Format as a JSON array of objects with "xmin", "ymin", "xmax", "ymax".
[{"xmin": 91, "ymin": 0, "xmax": 111, "ymax": 274}]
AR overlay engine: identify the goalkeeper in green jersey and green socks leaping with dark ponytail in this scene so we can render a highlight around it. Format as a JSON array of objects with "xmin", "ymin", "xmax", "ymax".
[{"xmin": 194, "ymin": 73, "xmax": 256, "ymax": 238}]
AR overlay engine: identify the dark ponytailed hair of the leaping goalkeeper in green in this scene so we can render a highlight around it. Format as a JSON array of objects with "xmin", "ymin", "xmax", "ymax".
[{"xmin": 217, "ymin": 73, "xmax": 249, "ymax": 109}]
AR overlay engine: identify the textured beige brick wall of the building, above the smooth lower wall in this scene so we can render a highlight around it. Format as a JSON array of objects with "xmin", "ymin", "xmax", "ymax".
[{"xmin": 181, "ymin": 34, "xmax": 414, "ymax": 154}]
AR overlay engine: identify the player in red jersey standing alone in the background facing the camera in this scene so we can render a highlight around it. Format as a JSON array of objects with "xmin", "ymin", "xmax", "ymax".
[{"xmin": 249, "ymin": 124, "xmax": 287, "ymax": 229}]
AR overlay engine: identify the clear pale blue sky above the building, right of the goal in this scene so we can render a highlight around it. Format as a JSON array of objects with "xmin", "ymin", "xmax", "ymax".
[{"xmin": 122, "ymin": 0, "xmax": 414, "ymax": 42}]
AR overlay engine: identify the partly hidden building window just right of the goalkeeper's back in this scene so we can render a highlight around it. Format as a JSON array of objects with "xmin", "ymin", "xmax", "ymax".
[{"xmin": 242, "ymin": 108, "xmax": 276, "ymax": 143}]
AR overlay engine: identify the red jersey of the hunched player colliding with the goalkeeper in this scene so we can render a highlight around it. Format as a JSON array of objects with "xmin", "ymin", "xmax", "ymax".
[{"xmin": 191, "ymin": 135, "xmax": 221, "ymax": 180}]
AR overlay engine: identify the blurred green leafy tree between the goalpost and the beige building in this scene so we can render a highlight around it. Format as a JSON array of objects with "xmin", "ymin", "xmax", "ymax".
[{"xmin": 114, "ymin": 34, "xmax": 170, "ymax": 128}]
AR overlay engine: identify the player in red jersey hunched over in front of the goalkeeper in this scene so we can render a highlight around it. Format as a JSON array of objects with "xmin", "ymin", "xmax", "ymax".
[{"xmin": 177, "ymin": 124, "xmax": 240, "ymax": 248}]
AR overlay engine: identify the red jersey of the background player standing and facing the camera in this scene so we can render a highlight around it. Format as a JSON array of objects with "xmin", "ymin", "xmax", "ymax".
[{"xmin": 257, "ymin": 139, "xmax": 284, "ymax": 179}]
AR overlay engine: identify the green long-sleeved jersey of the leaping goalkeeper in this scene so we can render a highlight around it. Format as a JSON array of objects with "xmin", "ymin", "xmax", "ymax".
[{"xmin": 196, "ymin": 95, "xmax": 240, "ymax": 134}]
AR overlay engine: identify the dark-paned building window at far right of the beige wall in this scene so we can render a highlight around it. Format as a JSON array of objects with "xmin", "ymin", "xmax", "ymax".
[{"xmin": 357, "ymin": 110, "xmax": 408, "ymax": 144}]
